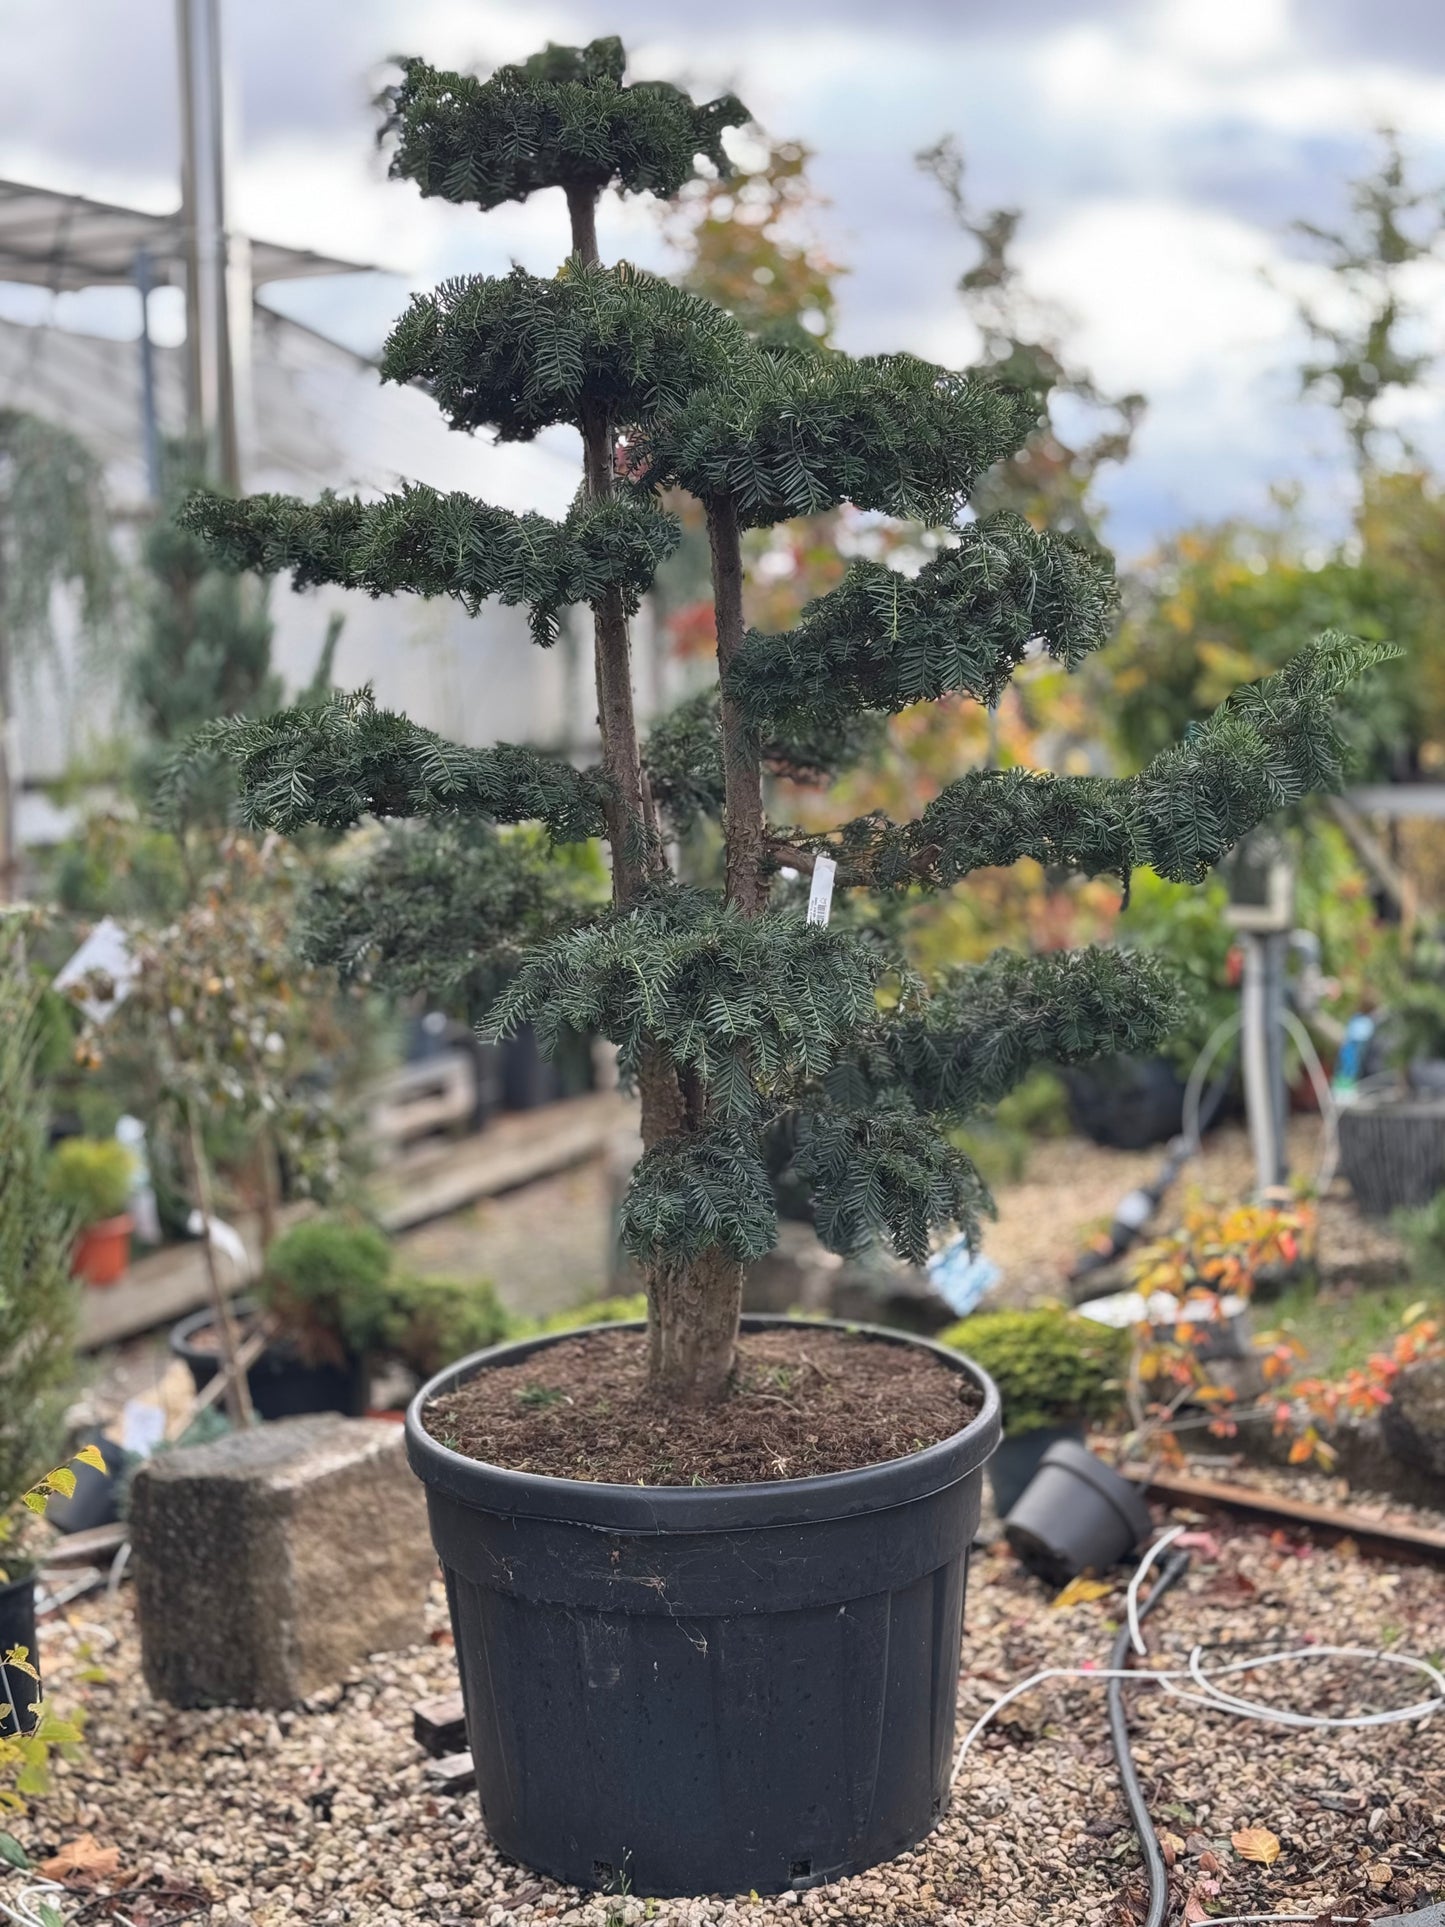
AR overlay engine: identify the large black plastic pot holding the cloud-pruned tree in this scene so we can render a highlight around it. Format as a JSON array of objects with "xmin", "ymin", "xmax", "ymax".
[{"xmin": 407, "ymin": 1316, "xmax": 998, "ymax": 1894}]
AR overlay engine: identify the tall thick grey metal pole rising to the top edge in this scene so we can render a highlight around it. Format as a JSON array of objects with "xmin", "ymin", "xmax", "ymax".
[{"xmin": 177, "ymin": 0, "xmax": 241, "ymax": 489}]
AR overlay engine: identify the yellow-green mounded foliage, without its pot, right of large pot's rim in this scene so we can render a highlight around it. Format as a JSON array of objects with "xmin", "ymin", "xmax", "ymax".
[{"xmin": 942, "ymin": 1305, "xmax": 1129, "ymax": 1436}]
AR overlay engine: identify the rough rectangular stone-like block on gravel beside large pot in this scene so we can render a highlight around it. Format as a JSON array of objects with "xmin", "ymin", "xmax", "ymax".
[{"xmin": 131, "ymin": 1412, "xmax": 435, "ymax": 1705}]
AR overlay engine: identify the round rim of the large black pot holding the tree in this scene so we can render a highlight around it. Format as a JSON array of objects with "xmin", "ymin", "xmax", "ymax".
[{"xmin": 407, "ymin": 1312, "xmax": 1002, "ymax": 1532}]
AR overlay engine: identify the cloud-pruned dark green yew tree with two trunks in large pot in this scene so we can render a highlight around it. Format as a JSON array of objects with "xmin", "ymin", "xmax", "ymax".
[{"xmin": 189, "ymin": 40, "xmax": 1394, "ymax": 1401}]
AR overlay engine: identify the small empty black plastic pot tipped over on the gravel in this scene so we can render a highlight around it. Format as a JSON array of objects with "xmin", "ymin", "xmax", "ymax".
[{"xmin": 1004, "ymin": 1439, "xmax": 1154, "ymax": 1586}]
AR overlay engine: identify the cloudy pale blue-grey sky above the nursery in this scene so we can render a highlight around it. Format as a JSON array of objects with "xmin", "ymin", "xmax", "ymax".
[{"xmin": 0, "ymin": 0, "xmax": 1445, "ymax": 553}]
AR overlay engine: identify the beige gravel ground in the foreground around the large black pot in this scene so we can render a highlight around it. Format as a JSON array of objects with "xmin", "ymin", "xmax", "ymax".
[{"xmin": 14, "ymin": 1515, "xmax": 1445, "ymax": 1927}]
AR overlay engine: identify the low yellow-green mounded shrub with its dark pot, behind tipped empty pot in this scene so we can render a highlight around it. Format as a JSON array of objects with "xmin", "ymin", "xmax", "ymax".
[{"xmin": 940, "ymin": 1305, "xmax": 1129, "ymax": 1517}]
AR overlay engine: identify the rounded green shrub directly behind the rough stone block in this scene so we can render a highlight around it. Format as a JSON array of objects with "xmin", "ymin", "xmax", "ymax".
[{"xmin": 260, "ymin": 1218, "xmax": 391, "ymax": 1357}]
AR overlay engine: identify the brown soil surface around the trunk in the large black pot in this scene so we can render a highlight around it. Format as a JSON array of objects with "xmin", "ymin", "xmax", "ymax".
[{"xmin": 426, "ymin": 1330, "xmax": 981, "ymax": 1486}]
